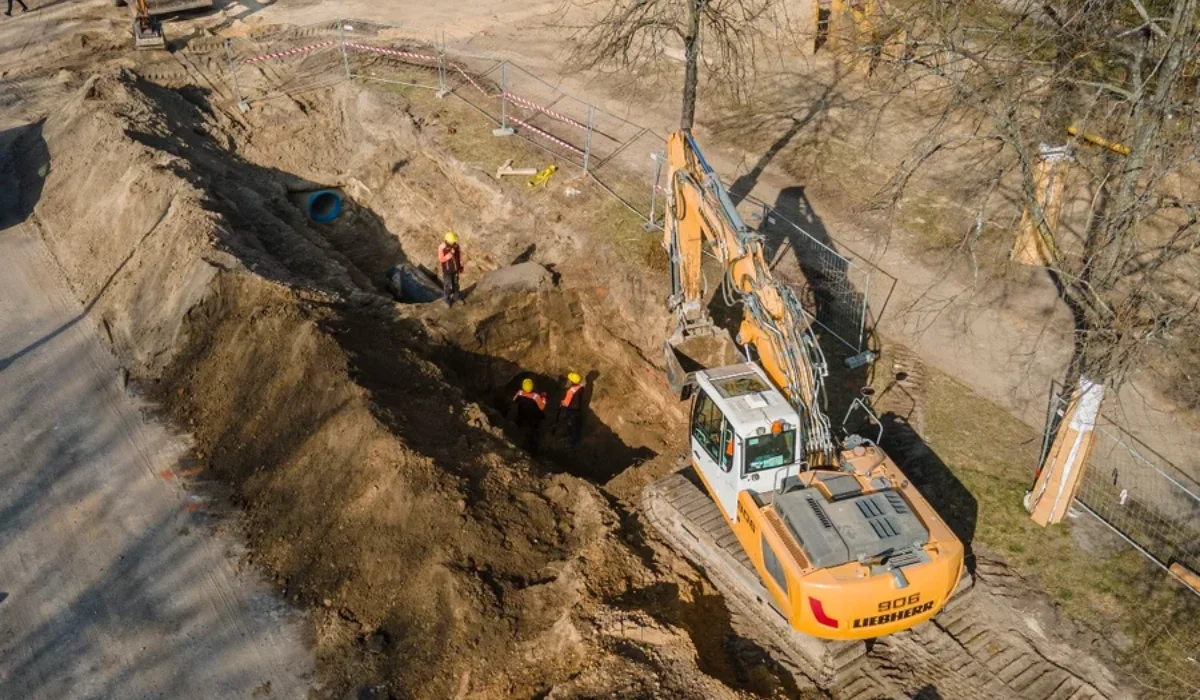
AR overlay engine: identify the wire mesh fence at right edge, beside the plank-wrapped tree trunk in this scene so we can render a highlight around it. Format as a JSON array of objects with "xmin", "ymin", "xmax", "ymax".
[{"xmin": 1039, "ymin": 395, "xmax": 1200, "ymax": 585}]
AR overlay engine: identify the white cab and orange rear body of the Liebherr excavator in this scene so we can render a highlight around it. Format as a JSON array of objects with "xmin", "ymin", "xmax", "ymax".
[{"xmin": 689, "ymin": 363, "xmax": 962, "ymax": 640}]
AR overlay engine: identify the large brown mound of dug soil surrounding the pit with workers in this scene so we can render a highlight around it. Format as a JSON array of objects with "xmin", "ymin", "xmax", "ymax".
[{"xmin": 25, "ymin": 73, "xmax": 796, "ymax": 699}]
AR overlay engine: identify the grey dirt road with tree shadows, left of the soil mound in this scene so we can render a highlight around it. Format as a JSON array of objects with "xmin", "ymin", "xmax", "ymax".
[{"xmin": 0, "ymin": 225, "xmax": 312, "ymax": 700}]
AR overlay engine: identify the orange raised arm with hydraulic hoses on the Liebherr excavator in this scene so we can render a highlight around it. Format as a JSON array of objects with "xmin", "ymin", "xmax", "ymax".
[{"xmin": 664, "ymin": 130, "xmax": 836, "ymax": 466}]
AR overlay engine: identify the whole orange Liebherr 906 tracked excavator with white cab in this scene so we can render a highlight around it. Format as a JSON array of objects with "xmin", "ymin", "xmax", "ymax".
[{"xmin": 643, "ymin": 130, "xmax": 966, "ymax": 686}]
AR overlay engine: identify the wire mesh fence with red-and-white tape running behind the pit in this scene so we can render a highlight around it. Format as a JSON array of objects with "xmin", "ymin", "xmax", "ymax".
[{"xmin": 192, "ymin": 19, "xmax": 871, "ymax": 353}]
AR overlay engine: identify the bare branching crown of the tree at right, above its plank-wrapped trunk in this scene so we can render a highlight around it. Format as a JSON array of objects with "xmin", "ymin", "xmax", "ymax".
[{"xmin": 881, "ymin": 0, "xmax": 1200, "ymax": 393}]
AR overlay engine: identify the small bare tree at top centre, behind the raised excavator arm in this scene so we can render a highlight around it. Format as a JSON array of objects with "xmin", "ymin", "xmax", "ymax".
[{"xmin": 574, "ymin": 0, "xmax": 779, "ymax": 128}]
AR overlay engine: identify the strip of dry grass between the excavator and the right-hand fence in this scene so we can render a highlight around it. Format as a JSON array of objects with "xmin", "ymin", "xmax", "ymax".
[{"xmin": 878, "ymin": 348, "xmax": 1200, "ymax": 700}]
